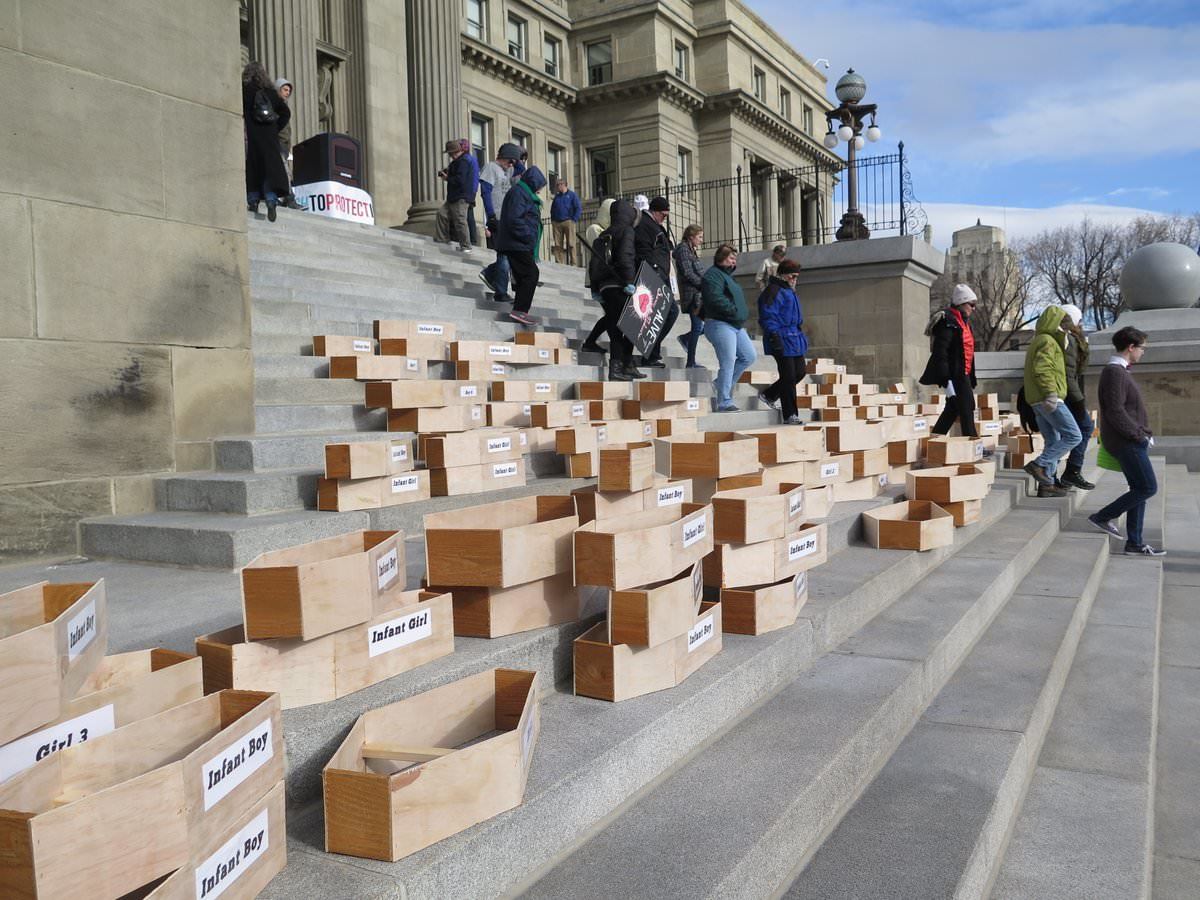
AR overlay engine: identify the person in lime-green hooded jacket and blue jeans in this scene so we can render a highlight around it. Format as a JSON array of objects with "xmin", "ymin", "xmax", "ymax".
[{"xmin": 1025, "ymin": 306, "xmax": 1081, "ymax": 497}]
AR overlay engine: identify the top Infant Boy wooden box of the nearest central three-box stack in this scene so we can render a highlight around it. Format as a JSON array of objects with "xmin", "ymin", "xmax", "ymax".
[{"xmin": 575, "ymin": 503, "xmax": 713, "ymax": 590}]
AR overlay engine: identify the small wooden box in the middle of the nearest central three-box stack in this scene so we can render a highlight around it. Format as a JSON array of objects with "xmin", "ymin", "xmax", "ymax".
[{"xmin": 608, "ymin": 563, "xmax": 704, "ymax": 647}]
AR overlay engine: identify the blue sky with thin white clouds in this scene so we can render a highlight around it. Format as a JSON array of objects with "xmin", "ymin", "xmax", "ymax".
[{"xmin": 746, "ymin": 0, "xmax": 1200, "ymax": 247}]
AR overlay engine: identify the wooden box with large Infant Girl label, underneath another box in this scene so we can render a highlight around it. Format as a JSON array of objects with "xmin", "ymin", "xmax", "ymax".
[{"xmin": 196, "ymin": 590, "xmax": 454, "ymax": 709}]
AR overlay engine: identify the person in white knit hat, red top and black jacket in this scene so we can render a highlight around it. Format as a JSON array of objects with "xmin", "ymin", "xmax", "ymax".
[{"xmin": 918, "ymin": 284, "xmax": 979, "ymax": 438}]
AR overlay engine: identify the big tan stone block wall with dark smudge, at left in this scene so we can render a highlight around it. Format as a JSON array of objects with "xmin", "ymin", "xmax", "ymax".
[{"xmin": 0, "ymin": 0, "xmax": 253, "ymax": 562}]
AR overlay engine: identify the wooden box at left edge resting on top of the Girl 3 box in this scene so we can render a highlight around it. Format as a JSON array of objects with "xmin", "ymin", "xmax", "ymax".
[{"xmin": 0, "ymin": 580, "xmax": 108, "ymax": 744}]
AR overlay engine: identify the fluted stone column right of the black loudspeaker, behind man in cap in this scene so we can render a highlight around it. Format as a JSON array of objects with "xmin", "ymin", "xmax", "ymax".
[{"xmin": 404, "ymin": 0, "xmax": 466, "ymax": 234}]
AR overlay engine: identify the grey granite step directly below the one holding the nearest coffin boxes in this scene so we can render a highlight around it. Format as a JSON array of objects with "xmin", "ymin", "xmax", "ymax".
[{"xmin": 516, "ymin": 508, "xmax": 1057, "ymax": 898}]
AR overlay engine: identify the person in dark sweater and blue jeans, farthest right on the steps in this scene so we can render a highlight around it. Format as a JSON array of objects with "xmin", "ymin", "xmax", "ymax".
[{"xmin": 1087, "ymin": 325, "xmax": 1166, "ymax": 557}]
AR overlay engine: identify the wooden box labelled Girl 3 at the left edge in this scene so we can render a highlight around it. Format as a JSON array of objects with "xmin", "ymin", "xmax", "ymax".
[{"xmin": 0, "ymin": 649, "xmax": 204, "ymax": 782}]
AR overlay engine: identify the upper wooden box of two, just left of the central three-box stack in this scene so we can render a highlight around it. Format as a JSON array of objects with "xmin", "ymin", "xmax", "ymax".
[{"xmin": 425, "ymin": 494, "xmax": 580, "ymax": 588}]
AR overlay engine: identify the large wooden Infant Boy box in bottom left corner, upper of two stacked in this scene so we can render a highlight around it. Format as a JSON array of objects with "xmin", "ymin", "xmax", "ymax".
[{"xmin": 0, "ymin": 691, "xmax": 283, "ymax": 900}]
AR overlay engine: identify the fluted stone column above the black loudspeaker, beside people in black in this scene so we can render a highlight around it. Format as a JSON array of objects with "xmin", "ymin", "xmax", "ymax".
[{"xmin": 251, "ymin": 0, "xmax": 318, "ymax": 144}]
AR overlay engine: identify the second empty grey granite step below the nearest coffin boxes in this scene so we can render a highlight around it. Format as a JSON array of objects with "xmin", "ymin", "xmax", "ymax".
[{"xmin": 784, "ymin": 534, "xmax": 1108, "ymax": 900}]
